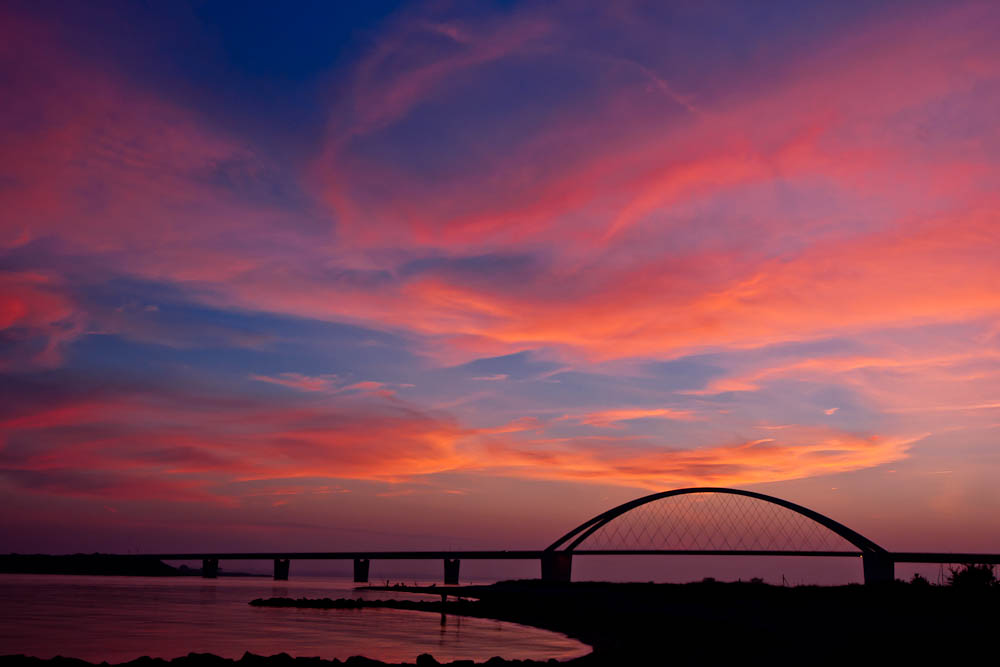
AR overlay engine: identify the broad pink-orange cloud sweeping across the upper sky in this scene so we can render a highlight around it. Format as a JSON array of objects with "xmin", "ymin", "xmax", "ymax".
[{"xmin": 3, "ymin": 1, "xmax": 998, "ymax": 370}]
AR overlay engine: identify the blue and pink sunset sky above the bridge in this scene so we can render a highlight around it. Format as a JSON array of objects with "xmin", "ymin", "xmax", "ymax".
[{"xmin": 0, "ymin": 0, "xmax": 1000, "ymax": 580}]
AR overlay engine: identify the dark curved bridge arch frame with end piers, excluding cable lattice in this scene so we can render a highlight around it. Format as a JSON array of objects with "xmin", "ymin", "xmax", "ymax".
[{"xmin": 543, "ymin": 487, "xmax": 894, "ymax": 583}]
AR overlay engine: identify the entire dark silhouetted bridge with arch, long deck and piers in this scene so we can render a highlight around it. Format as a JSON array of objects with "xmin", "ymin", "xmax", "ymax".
[{"xmin": 141, "ymin": 487, "xmax": 1000, "ymax": 584}]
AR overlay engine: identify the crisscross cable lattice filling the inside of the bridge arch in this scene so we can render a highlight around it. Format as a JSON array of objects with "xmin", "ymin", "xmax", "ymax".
[{"xmin": 577, "ymin": 493, "xmax": 857, "ymax": 551}]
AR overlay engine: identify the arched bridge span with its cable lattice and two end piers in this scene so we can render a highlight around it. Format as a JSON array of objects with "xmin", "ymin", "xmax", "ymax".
[{"xmin": 542, "ymin": 487, "xmax": 894, "ymax": 583}]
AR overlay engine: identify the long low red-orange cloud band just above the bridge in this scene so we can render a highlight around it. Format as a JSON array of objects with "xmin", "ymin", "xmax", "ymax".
[{"xmin": 0, "ymin": 368, "xmax": 916, "ymax": 503}]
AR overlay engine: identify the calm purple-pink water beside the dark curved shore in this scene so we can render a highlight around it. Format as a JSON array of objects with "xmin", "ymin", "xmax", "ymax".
[{"xmin": 0, "ymin": 574, "xmax": 590, "ymax": 662}]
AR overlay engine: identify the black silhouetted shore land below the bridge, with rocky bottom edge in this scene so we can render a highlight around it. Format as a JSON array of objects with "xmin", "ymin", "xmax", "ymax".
[{"xmin": 4, "ymin": 581, "xmax": 1000, "ymax": 667}]
